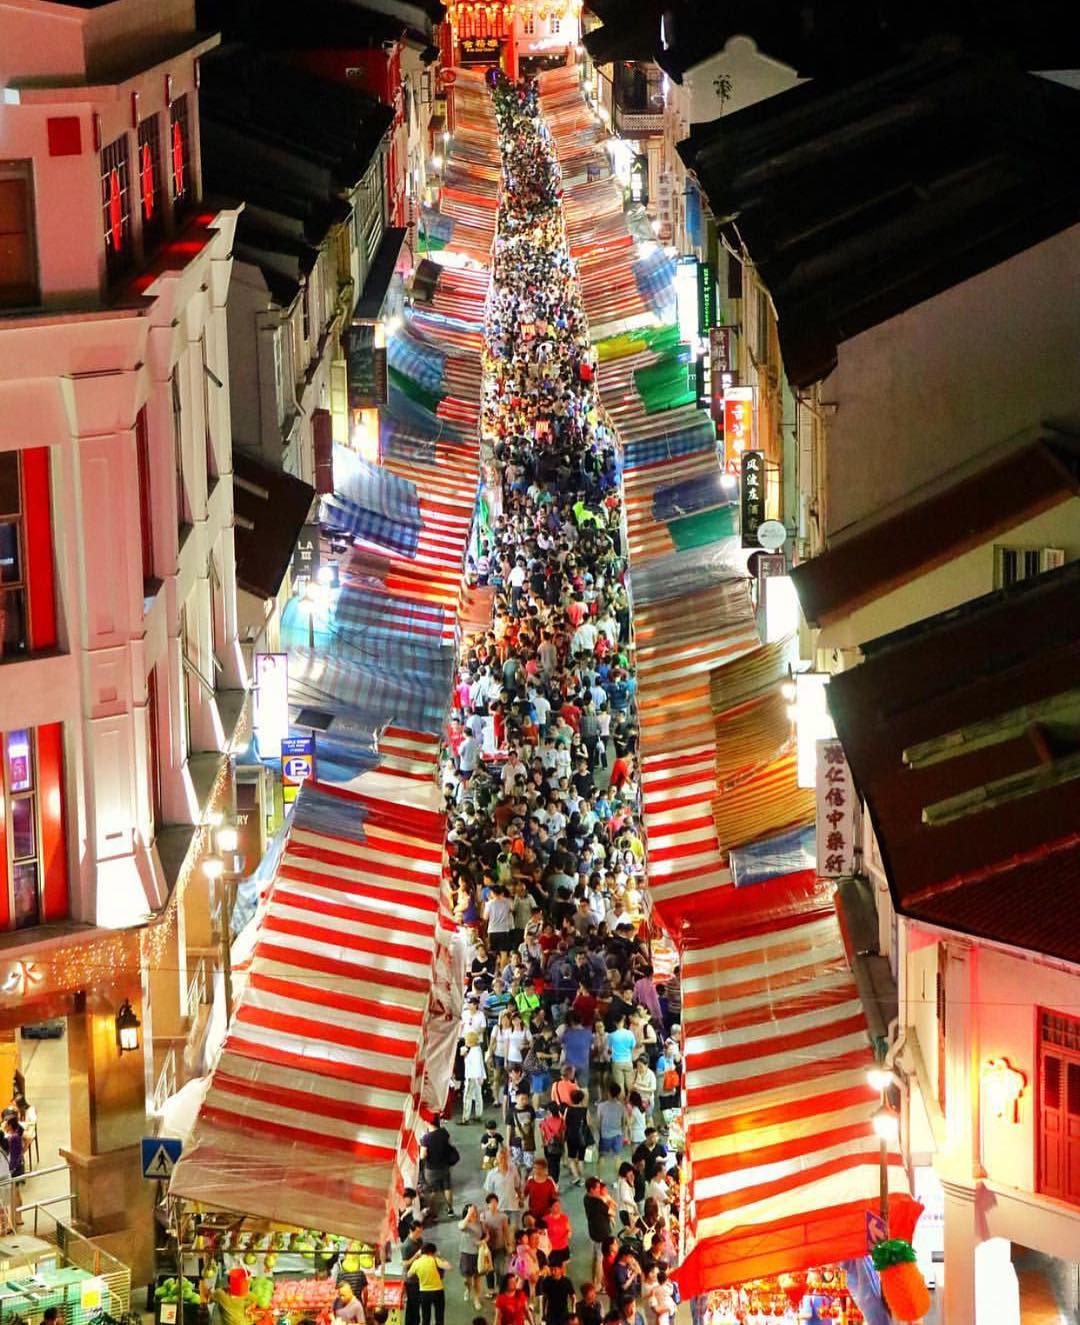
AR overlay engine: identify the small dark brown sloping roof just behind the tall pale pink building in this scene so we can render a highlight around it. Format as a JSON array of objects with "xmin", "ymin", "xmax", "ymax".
[{"xmin": 232, "ymin": 451, "xmax": 315, "ymax": 598}]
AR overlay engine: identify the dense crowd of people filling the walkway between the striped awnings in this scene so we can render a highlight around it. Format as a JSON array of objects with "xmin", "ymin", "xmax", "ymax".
[{"xmin": 398, "ymin": 76, "xmax": 681, "ymax": 1325}]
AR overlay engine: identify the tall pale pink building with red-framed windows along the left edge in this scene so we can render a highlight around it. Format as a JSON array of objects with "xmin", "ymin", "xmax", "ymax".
[{"xmin": 0, "ymin": 0, "xmax": 248, "ymax": 1272}]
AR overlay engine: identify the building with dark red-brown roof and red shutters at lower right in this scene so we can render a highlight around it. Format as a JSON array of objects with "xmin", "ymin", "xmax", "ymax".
[{"xmin": 828, "ymin": 575, "xmax": 1080, "ymax": 1325}]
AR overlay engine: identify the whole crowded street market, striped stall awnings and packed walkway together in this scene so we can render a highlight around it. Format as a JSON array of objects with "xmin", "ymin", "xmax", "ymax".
[{"xmin": 162, "ymin": 51, "xmax": 921, "ymax": 1325}]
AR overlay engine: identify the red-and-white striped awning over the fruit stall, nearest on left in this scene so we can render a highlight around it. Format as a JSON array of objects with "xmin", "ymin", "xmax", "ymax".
[{"xmin": 171, "ymin": 784, "xmax": 445, "ymax": 1242}]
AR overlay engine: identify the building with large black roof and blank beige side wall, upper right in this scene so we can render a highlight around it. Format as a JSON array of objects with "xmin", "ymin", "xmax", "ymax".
[{"xmin": 681, "ymin": 45, "xmax": 1080, "ymax": 558}]
